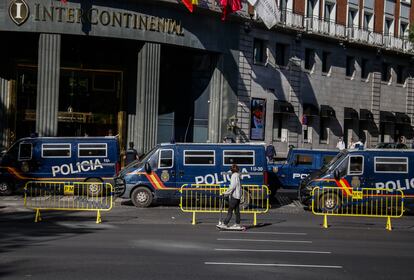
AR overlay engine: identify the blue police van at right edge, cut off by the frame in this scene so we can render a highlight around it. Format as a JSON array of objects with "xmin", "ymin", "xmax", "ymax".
[{"xmin": 300, "ymin": 148, "xmax": 414, "ymax": 209}]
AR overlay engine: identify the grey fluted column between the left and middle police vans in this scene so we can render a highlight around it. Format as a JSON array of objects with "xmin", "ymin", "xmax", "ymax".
[{"xmin": 128, "ymin": 43, "xmax": 161, "ymax": 153}]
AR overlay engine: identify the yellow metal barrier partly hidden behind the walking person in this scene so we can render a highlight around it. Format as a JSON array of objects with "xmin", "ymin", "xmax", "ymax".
[{"xmin": 180, "ymin": 184, "xmax": 270, "ymax": 225}]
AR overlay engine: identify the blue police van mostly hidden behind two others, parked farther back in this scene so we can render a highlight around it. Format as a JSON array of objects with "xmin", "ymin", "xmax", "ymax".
[{"xmin": 268, "ymin": 148, "xmax": 339, "ymax": 196}]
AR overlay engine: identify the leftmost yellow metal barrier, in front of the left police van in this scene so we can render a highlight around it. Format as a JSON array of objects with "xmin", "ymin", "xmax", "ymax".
[{"xmin": 24, "ymin": 181, "xmax": 114, "ymax": 223}]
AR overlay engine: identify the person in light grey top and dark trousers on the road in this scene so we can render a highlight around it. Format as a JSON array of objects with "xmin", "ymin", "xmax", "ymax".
[{"xmin": 223, "ymin": 164, "xmax": 242, "ymax": 228}]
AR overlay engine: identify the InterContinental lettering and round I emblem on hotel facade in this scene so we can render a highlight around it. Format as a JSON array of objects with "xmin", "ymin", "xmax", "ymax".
[{"xmin": 9, "ymin": 0, "xmax": 184, "ymax": 36}]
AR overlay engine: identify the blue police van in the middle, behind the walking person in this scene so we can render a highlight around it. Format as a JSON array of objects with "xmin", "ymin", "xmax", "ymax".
[{"xmin": 116, "ymin": 143, "xmax": 267, "ymax": 207}]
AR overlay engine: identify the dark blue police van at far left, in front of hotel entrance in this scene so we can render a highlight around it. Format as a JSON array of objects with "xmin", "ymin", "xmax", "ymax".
[{"xmin": 0, "ymin": 136, "xmax": 120, "ymax": 195}]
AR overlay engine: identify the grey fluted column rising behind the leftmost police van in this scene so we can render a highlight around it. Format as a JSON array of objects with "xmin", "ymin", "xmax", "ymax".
[{"xmin": 36, "ymin": 34, "xmax": 61, "ymax": 136}]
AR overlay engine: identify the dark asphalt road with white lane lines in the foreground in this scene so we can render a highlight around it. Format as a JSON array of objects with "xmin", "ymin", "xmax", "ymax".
[{"xmin": 0, "ymin": 198, "xmax": 414, "ymax": 280}]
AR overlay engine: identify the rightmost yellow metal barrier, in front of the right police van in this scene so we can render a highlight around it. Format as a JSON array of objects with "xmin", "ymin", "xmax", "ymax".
[{"xmin": 312, "ymin": 187, "xmax": 404, "ymax": 230}]
